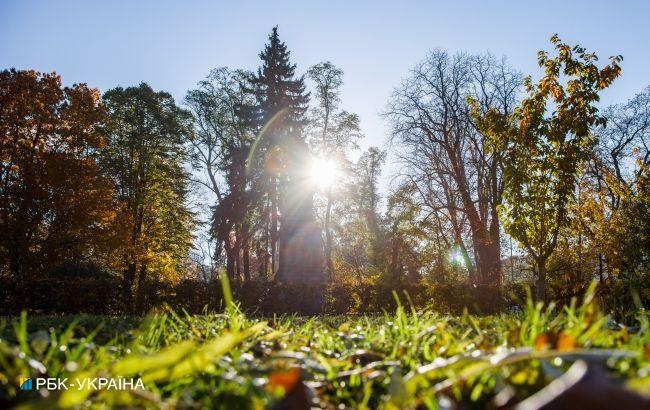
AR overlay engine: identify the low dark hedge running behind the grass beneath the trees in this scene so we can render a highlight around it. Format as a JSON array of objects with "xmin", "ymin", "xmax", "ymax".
[{"xmin": 0, "ymin": 265, "xmax": 592, "ymax": 316}]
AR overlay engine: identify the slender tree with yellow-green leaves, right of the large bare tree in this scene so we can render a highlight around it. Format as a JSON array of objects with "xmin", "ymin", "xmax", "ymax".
[{"xmin": 473, "ymin": 35, "xmax": 621, "ymax": 300}]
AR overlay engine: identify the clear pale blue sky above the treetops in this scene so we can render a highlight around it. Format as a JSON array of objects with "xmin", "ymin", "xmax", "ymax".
[{"xmin": 0, "ymin": 0, "xmax": 650, "ymax": 186}]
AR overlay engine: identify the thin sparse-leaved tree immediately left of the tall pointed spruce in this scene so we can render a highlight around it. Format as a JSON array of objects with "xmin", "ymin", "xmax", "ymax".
[{"xmin": 185, "ymin": 68, "xmax": 259, "ymax": 280}]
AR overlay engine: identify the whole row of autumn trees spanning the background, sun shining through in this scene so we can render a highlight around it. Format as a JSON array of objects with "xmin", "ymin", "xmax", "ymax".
[{"xmin": 0, "ymin": 27, "xmax": 650, "ymax": 312}]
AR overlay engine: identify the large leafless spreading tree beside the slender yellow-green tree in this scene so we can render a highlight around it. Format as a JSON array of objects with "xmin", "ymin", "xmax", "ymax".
[{"xmin": 384, "ymin": 50, "xmax": 520, "ymax": 285}]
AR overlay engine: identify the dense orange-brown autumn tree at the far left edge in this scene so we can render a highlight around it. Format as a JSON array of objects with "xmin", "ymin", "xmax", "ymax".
[{"xmin": 0, "ymin": 69, "xmax": 115, "ymax": 280}]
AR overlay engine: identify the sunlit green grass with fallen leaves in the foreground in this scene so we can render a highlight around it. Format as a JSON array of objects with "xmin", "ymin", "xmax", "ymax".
[{"xmin": 0, "ymin": 286, "xmax": 650, "ymax": 409}]
